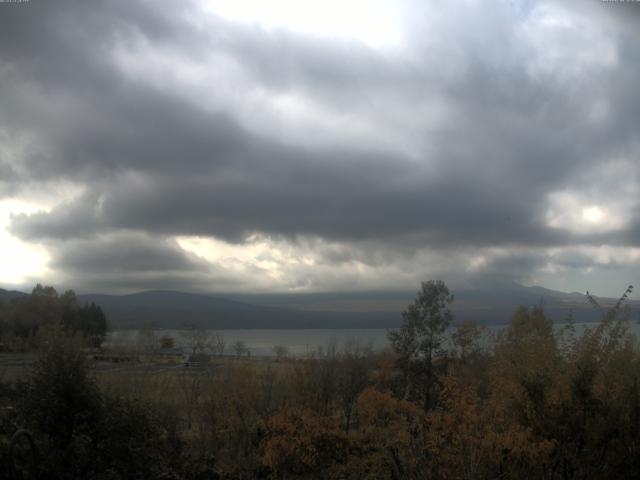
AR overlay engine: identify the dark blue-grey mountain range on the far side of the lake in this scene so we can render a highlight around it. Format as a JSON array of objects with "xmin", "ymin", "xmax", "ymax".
[{"xmin": 0, "ymin": 283, "xmax": 640, "ymax": 329}]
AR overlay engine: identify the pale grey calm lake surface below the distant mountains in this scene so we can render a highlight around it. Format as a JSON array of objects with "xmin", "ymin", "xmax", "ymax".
[{"xmin": 106, "ymin": 322, "xmax": 640, "ymax": 356}]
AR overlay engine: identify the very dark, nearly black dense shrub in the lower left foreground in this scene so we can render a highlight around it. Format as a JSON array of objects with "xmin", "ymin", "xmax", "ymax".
[{"xmin": 13, "ymin": 328, "xmax": 182, "ymax": 480}]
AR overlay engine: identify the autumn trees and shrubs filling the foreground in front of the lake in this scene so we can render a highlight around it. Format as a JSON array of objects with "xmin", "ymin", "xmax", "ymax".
[{"xmin": 0, "ymin": 281, "xmax": 640, "ymax": 480}]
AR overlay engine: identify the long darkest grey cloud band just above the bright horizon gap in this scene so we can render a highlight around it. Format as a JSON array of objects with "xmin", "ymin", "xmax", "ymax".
[{"xmin": 12, "ymin": 164, "xmax": 570, "ymax": 246}]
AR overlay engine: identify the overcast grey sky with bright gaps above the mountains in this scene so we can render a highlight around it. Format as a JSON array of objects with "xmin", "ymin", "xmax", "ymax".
[{"xmin": 0, "ymin": 0, "xmax": 640, "ymax": 295}]
